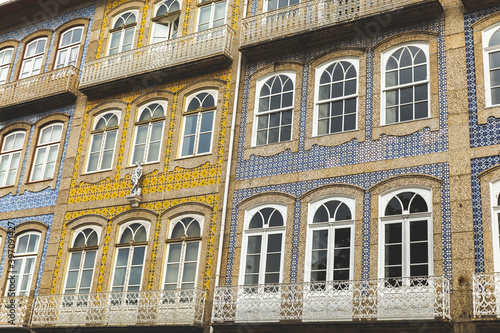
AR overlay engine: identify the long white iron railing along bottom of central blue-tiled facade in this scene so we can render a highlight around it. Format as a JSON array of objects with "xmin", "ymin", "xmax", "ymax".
[{"xmin": 212, "ymin": 276, "xmax": 451, "ymax": 323}]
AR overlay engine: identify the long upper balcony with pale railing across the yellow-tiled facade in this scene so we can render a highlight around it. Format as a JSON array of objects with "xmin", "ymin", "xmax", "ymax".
[{"xmin": 80, "ymin": 25, "xmax": 234, "ymax": 95}]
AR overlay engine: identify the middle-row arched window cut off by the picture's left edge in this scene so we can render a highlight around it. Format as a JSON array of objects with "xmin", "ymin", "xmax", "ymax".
[{"xmin": 0, "ymin": 131, "xmax": 26, "ymax": 187}]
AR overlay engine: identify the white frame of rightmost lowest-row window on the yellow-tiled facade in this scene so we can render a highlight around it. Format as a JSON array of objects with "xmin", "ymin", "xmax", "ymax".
[{"xmin": 161, "ymin": 214, "xmax": 204, "ymax": 290}]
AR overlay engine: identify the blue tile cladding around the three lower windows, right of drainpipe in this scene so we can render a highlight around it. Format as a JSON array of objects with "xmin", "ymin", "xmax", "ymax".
[{"xmin": 226, "ymin": 163, "xmax": 452, "ymax": 285}]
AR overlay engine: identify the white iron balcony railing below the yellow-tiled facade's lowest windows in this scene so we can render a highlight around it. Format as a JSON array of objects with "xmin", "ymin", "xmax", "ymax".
[{"xmin": 31, "ymin": 289, "xmax": 206, "ymax": 327}]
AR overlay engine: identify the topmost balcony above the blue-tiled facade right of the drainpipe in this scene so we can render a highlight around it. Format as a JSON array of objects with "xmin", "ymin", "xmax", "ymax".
[{"xmin": 240, "ymin": 0, "xmax": 443, "ymax": 59}]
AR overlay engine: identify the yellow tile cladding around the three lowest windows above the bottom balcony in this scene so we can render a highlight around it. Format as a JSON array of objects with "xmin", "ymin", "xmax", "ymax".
[{"xmin": 51, "ymin": 194, "xmax": 218, "ymax": 294}]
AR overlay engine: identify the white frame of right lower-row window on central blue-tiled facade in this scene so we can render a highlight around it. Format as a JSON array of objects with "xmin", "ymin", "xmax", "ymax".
[{"xmin": 378, "ymin": 186, "xmax": 434, "ymax": 283}]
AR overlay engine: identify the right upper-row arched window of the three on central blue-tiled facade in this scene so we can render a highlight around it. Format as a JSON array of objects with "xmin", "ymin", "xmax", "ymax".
[{"xmin": 382, "ymin": 43, "xmax": 429, "ymax": 124}]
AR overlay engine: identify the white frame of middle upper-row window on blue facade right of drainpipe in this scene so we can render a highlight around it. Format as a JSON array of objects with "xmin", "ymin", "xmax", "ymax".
[{"xmin": 313, "ymin": 57, "xmax": 359, "ymax": 136}]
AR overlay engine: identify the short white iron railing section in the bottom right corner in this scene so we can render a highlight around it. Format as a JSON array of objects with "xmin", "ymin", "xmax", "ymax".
[{"xmin": 472, "ymin": 273, "xmax": 500, "ymax": 317}]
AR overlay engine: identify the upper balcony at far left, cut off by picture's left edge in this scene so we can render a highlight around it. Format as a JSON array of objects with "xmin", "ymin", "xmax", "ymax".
[{"xmin": 0, "ymin": 66, "xmax": 80, "ymax": 119}]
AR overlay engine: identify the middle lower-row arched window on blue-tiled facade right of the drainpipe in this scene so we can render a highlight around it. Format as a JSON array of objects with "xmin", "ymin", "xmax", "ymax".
[{"xmin": 305, "ymin": 198, "xmax": 354, "ymax": 282}]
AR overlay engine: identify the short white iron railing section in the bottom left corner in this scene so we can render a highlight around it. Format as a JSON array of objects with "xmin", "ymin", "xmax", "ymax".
[{"xmin": 0, "ymin": 296, "xmax": 33, "ymax": 330}]
